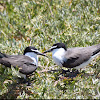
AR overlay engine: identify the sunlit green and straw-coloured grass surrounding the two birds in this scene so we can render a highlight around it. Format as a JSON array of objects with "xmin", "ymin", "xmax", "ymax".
[{"xmin": 0, "ymin": 0, "xmax": 100, "ymax": 99}]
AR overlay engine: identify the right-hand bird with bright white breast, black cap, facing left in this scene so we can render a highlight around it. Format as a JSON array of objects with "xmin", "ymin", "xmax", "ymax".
[{"xmin": 43, "ymin": 43, "xmax": 100, "ymax": 70}]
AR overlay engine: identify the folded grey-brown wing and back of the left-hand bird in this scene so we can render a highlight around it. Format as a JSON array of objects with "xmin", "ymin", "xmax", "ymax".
[{"xmin": 2, "ymin": 55, "xmax": 37, "ymax": 74}]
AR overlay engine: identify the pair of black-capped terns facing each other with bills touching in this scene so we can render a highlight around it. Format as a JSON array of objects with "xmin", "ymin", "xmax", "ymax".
[{"xmin": 0, "ymin": 43, "xmax": 100, "ymax": 78}]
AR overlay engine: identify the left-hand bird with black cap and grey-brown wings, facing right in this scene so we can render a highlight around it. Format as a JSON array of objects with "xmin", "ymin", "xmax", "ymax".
[{"xmin": 0, "ymin": 46, "xmax": 47, "ymax": 79}]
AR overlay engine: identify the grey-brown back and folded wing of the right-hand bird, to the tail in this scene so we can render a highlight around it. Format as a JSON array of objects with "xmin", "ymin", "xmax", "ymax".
[{"xmin": 63, "ymin": 44, "xmax": 100, "ymax": 68}]
